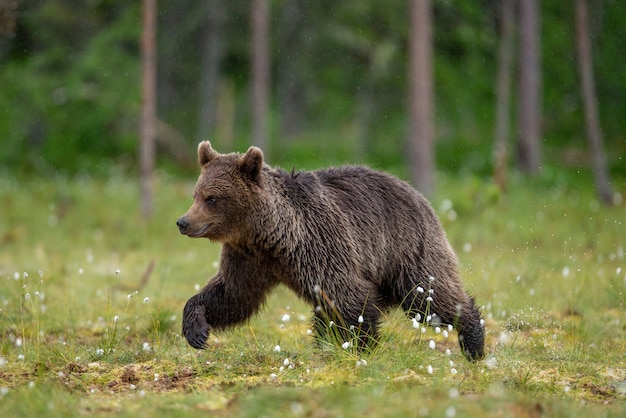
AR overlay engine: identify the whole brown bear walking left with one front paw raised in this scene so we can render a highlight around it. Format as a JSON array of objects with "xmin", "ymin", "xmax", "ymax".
[{"xmin": 176, "ymin": 142, "xmax": 484, "ymax": 360}]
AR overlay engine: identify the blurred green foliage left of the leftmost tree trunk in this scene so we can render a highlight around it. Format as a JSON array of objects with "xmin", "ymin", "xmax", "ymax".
[{"xmin": 0, "ymin": 1, "xmax": 140, "ymax": 173}]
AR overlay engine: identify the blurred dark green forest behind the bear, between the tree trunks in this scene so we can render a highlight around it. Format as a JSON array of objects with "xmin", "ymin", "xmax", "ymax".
[{"xmin": 0, "ymin": 0, "xmax": 626, "ymax": 194}]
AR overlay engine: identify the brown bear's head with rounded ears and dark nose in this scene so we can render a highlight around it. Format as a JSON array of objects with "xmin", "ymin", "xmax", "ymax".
[{"xmin": 176, "ymin": 141, "xmax": 263, "ymax": 243}]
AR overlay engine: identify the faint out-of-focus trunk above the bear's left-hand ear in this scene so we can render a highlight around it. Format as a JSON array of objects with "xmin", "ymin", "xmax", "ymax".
[{"xmin": 197, "ymin": 0, "xmax": 227, "ymax": 145}]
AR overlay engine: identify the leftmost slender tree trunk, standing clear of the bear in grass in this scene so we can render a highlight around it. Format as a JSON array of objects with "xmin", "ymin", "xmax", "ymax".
[{"xmin": 139, "ymin": 0, "xmax": 156, "ymax": 217}]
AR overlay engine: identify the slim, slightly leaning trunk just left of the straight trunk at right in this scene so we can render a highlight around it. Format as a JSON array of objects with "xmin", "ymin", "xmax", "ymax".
[{"xmin": 493, "ymin": 0, "xmax": 516, "ymax": 191}]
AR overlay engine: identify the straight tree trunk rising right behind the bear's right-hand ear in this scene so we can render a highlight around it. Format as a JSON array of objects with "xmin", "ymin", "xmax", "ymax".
[{"xmin": 251, "ymin": 0, "xmax": 270, "ymax": 155}]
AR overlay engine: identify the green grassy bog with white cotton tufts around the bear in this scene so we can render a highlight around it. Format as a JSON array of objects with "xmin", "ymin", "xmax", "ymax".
[{"xmin": 0, "ymin": 169, "xmax": 626, "ymax": 417}]
